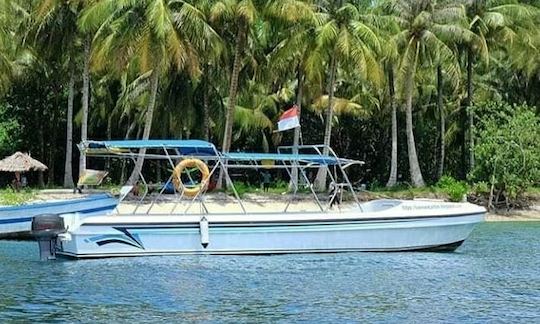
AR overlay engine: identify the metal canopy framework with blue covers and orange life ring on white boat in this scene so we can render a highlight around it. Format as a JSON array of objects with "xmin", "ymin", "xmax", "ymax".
[{"xmin": 79, "ymin": 141, "xmax": 363, "ymax": 215}]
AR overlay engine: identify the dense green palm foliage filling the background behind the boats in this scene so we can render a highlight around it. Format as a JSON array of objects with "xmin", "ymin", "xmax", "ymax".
[{"xmin": 0, "ymin": 0, "xmax": 540, "ymax": 192}]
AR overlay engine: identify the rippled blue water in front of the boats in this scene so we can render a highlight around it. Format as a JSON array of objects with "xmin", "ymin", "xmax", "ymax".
[{"xmin": 0, "ymin": 223, "xmax": 540, "ymax": 322}]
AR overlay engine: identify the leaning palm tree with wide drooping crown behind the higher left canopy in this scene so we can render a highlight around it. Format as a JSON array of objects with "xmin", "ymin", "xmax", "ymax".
[{"xmin": 81, "ymin": 0, "xmax": 199, "ymax": 183}]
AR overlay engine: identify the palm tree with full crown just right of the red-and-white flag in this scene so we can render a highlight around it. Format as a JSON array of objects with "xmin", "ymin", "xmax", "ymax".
[{"xmin": 315, "ymin": 3, "xmax": 381, "ymax": 190}]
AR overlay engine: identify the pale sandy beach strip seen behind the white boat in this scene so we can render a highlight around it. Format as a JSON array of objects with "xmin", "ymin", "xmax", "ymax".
[{"xmin": 32, "ymin": 190, "xmax": 540, "ymax": 222}]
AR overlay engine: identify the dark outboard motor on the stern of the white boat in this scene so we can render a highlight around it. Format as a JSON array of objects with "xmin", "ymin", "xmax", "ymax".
[{"xmin": 31, "ymin": 214, "xmax": 66, "ymax": 261}]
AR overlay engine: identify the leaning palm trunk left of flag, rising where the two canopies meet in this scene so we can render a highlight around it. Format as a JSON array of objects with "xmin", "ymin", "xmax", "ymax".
[{"xmin": 221, "ymin": 20, "xmax": 247, "ymax": 153}]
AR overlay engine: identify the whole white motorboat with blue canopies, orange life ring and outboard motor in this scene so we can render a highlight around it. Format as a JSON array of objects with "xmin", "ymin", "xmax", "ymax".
[{"xmin": 29, "ymin": 140, "xmax": 486, "ymax": 258}]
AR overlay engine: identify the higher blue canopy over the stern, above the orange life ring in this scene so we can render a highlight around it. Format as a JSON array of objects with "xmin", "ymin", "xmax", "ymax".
[{"xmin": 82, "ymin": 139, "xmax": 216, "ymax": 156}]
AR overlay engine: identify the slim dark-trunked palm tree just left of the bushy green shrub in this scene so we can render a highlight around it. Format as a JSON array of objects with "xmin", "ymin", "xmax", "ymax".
[{"xmin": 461, "ymin": 0, "xmax": 535, "ymax": 170}]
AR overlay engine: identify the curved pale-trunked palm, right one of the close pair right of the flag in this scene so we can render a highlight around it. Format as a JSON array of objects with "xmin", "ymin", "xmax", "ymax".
[{"xmin": 392, "ymin": 0, "xmax": 470, "ymax": 187}]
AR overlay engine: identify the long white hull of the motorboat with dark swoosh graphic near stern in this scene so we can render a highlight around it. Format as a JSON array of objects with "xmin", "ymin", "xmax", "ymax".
[{"xmin": 57, "ymin": 212, "xmax": 484, "ymax": 258}]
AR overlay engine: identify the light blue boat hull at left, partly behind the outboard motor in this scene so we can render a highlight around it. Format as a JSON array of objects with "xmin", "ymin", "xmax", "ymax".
[{"xmin": 0, "ymin": 194, "xmax": 118, "ymax": 236}]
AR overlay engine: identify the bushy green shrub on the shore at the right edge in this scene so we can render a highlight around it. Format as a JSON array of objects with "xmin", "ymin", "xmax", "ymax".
[{"xmin": 470, "ymin": 103, "xmax": 540, "ymax": 199}]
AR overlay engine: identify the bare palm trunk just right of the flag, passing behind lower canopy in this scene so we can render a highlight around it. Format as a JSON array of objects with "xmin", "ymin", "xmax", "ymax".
[{"xmin": 315, "ymin": 55, "xmax": 337, "ymax": 191}]
